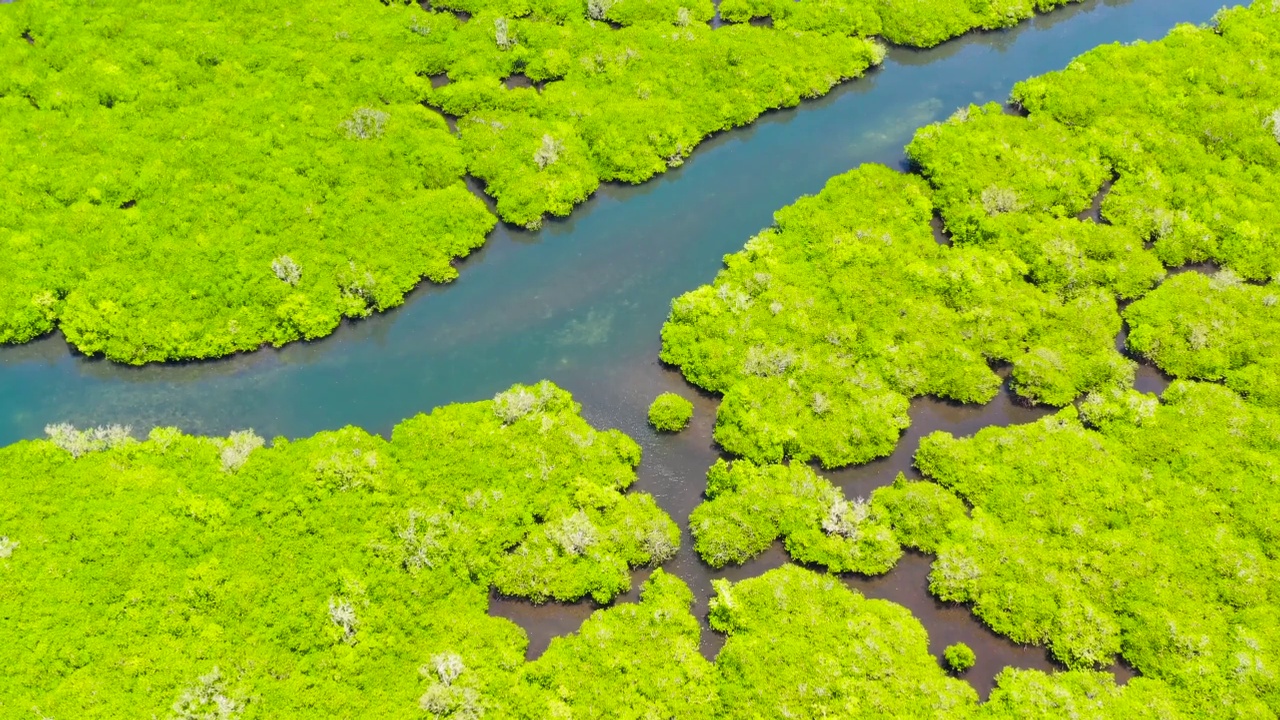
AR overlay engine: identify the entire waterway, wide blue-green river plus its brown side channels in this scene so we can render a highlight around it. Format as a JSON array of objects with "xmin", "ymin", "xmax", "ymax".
[{"xmin": 0, "ymin": 0, "xmax": 1220, "ymax": 694}]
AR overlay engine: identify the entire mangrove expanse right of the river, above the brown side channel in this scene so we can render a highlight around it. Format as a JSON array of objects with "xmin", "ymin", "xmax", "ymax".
[{"xmin": 662, "ymin": 3, "xmax": 1280, "ymax": 466}]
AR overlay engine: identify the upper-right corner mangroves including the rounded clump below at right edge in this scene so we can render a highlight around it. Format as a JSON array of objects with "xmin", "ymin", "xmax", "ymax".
[{"xmin": 909, "ymin": 1, "xmax": 1280, "ymax": 405}]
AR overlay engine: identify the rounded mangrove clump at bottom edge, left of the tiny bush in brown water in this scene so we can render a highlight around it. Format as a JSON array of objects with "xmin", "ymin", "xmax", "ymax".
[{"xmin": 710, "ymin": 565, "xmax": 978, "ymax": 719}]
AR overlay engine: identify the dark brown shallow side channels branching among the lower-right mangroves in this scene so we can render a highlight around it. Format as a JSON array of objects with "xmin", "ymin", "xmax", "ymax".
[{"xmin": 490, "ymin": 347, "xmax": 1167, "ymax": 697}]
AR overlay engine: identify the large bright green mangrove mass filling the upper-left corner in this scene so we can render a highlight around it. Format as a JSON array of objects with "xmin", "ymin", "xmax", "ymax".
[{"xmin": 0, "ymin": 0, "xmax": 494, "ymax": 363}]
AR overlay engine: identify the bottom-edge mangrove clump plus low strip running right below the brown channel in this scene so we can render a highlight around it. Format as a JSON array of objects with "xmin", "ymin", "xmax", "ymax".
[{"xmin": 710, "ymin": 565, "xmax": 1176, "ymax": 720}]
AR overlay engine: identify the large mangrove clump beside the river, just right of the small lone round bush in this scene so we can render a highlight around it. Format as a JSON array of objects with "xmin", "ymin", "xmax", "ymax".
[{"xmin": 662, "ymin": 165, "xmax": 1133, "ymax": 466}]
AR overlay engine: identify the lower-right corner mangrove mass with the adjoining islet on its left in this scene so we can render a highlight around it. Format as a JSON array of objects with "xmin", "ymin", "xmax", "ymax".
[{"xmin": 690, "ymin": 382, "xmax": 1280, "ymax": 717}]
